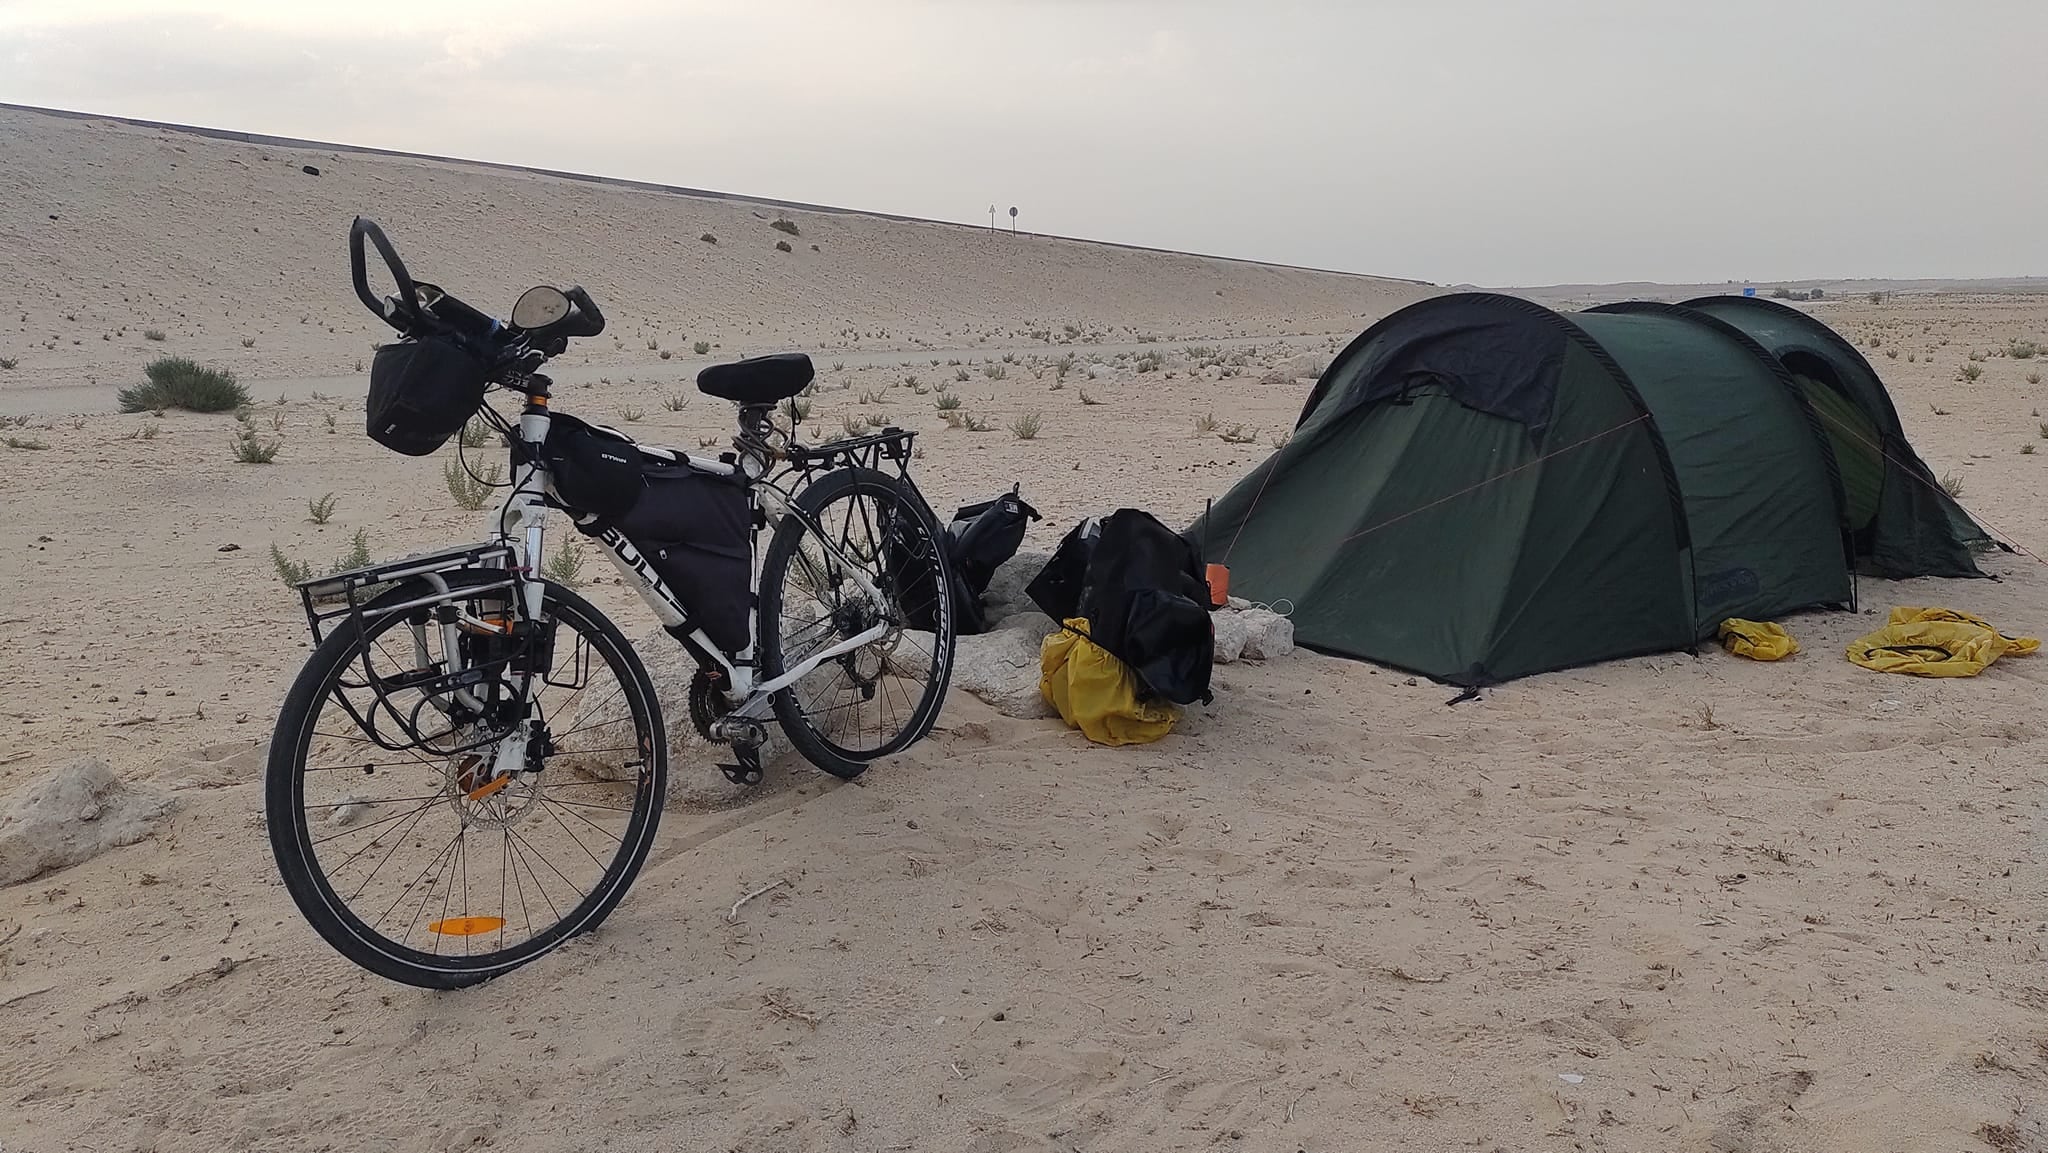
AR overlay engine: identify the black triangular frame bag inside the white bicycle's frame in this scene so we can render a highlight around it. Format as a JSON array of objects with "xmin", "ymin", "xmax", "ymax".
[{"xmin": 614, "ymin": 461, "xmax": 754, "ymax": 653}]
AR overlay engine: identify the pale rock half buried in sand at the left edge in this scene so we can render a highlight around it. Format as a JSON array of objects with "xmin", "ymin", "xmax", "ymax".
[{"xmin": 0, "ymin": 758, "xmax": 170, "ymax": 885}]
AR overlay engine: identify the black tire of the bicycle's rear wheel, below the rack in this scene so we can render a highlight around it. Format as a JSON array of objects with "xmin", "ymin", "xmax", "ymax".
[{"xmin": 760, "ymin": 467, "xmax": 954, "ymax": 780}]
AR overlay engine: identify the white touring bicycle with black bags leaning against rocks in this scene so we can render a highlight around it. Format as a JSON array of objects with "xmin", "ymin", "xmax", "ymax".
[{"xmin": 264, "ymin": 217, "xmax": 954, "ymax": 989}]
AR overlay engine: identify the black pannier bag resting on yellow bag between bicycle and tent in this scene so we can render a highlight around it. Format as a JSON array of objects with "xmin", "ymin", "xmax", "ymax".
[{"xmin": 1024, "ymin": 508, "xmax": 1217, "ymax": 704}]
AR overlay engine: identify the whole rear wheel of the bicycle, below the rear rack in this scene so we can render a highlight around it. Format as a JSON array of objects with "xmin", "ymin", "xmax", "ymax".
[{"xmin": 760, "ymin": 467, "xmax": 954, "ymax": 778}]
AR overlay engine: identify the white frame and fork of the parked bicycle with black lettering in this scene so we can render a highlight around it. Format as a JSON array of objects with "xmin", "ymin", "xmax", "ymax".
[{"xmin": 489, "ymin": 401, "xmax": 889, "ymax": 716}]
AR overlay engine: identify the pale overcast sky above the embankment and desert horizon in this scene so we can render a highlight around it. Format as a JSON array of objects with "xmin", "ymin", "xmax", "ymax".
[{"xmin": 0, "ymin": 0, "xmax": 2048, "ymax": 285}]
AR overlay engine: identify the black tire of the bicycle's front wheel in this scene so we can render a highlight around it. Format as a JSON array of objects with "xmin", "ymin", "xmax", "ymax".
[{"xmin": 264, "ymin": 571, "xmax": 668, "ymax": 989}]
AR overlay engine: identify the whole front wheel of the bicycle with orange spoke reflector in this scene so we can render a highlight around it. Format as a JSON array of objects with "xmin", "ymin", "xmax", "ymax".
[{"xmin": 264, "ymin": 573, "xmax": 668, "ymax": 989}]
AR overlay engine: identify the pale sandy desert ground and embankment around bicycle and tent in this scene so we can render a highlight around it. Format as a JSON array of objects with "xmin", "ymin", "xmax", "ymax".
[{"xmin": 0, "ymin": 115, "xmax": 2048, "ymax": 1153}]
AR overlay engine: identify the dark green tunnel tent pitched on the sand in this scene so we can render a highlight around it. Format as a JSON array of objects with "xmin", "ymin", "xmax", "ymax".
[{"xmin": 1188, "ymin": 293, "xmax": 1974, "ymax": 684}]
